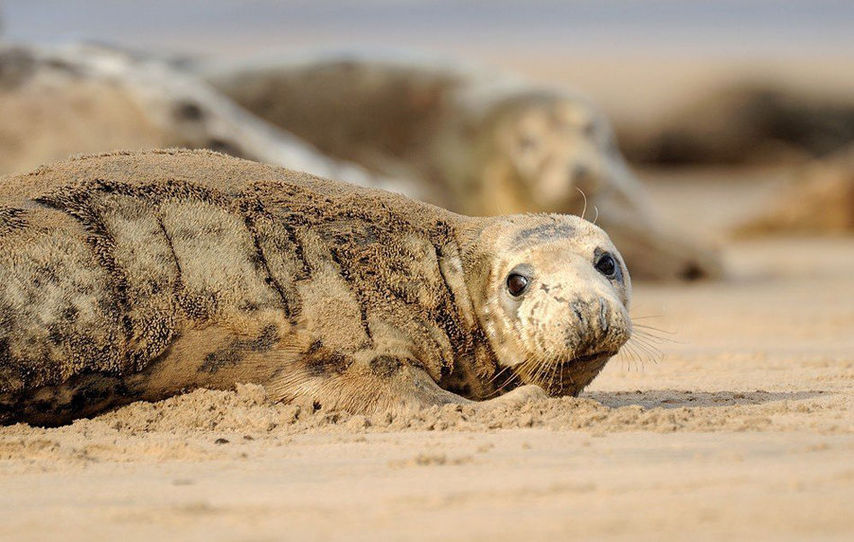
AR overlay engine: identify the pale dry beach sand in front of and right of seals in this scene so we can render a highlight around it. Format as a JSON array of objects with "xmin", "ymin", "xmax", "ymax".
[{"xmin": 0, "ymin": 175, "xmax": 854, "ymax": 541}]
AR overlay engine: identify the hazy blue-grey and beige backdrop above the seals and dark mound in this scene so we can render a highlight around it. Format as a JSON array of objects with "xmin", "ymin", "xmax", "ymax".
[{"xmin": 8, "ymin": 0, "xmax": 854, "ymax": 133}]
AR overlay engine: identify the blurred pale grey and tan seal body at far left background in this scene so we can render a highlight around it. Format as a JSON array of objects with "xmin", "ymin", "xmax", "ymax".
[{"xmin": 0, "ymin": 44, "xmax": 418, "ymax": 196}]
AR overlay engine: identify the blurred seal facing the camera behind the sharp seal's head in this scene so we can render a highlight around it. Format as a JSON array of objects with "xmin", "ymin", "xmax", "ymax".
[{"xmin": 207, "ymin": 54, "xmax": 722, "ymax": 280}]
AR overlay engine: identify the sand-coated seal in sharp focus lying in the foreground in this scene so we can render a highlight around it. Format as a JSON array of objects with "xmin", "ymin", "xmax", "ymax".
[{"xmin": 0, "ymin": 150, "xmax": 632, "ymax": 424}]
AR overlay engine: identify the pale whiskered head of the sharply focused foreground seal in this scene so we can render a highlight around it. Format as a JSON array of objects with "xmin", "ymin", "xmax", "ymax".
[{"xmin": 461, "ymin": 214, "xmax": 632, "ymax": 396}]
